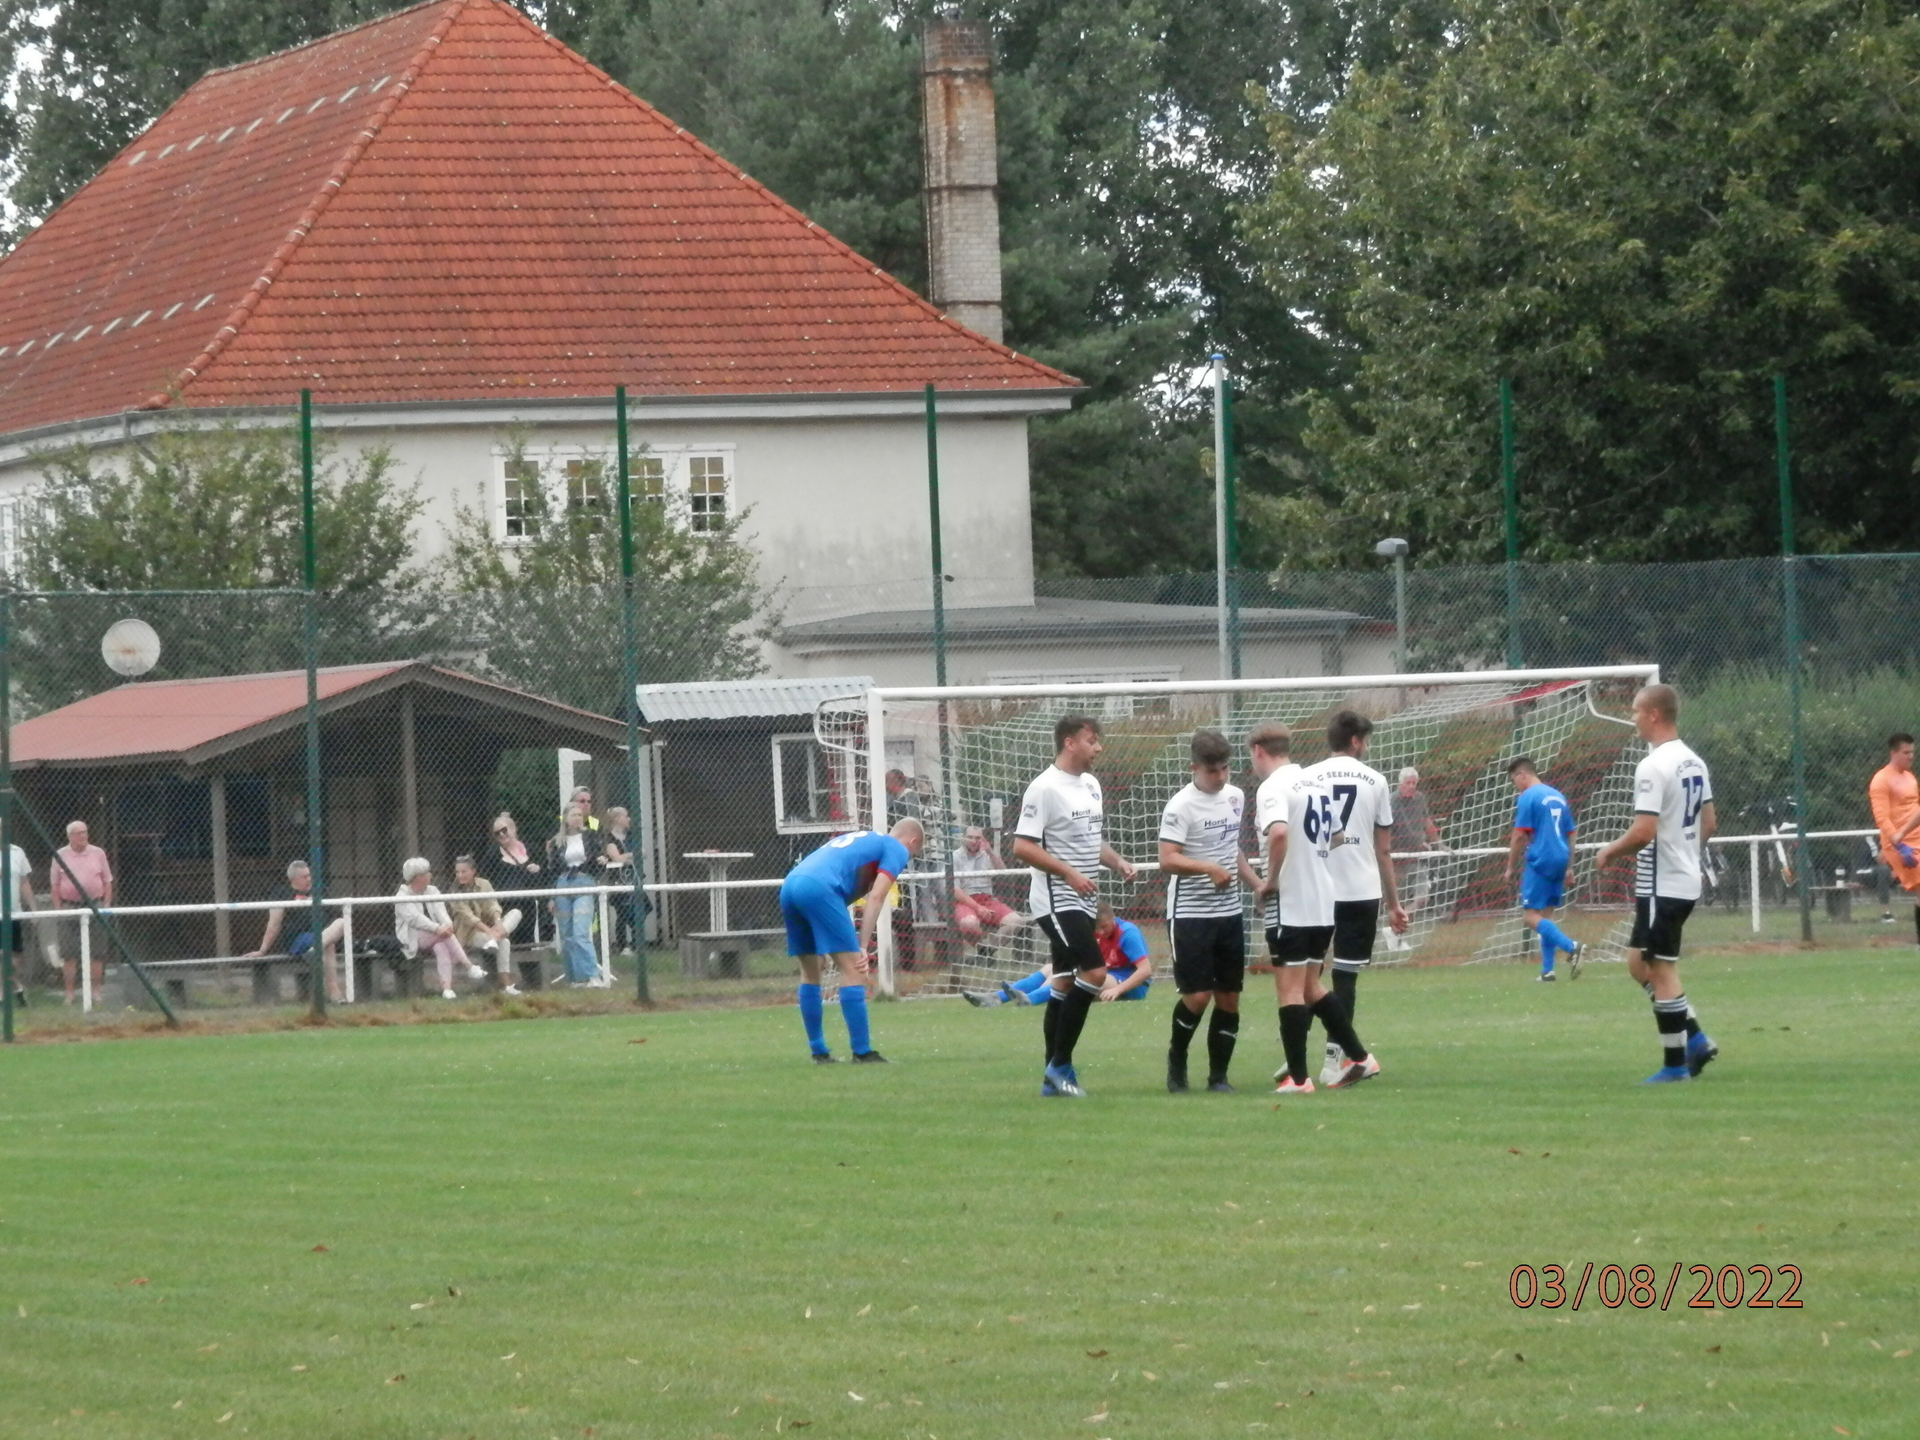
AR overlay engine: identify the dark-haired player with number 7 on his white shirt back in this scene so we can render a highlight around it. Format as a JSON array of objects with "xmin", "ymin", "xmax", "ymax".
[{"xmin": 1308, "ymin": 710, "xmax": 1407, "ymax": 1085}]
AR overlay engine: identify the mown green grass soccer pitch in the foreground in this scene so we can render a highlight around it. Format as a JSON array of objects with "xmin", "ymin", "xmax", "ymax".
[{"xmin": 0, "ymin": 950, "xmax": 1920, "ymax": 1440}]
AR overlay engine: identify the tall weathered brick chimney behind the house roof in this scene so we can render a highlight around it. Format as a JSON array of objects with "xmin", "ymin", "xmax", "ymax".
[{"xmin": 920, "ymin": 19, "xmax": 1004, "ymax": 340}]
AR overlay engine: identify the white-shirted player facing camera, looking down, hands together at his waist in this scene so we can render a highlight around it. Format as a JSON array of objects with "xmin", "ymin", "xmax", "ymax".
[{"xmin": 1160, "ymin": 730, "xmax": 1260, "ymax": 1094}]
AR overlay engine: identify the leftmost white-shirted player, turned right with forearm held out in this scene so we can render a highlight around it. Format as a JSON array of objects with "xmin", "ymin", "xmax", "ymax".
[{"xmin": 1014, "ymin": 714, "xmax": 1133, "ymax": 1096}]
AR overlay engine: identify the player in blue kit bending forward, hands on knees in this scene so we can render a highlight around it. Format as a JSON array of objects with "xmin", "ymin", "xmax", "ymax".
[{"xmin": 780, "ymin": 820, "xmax": 925, "ymax": 1066}]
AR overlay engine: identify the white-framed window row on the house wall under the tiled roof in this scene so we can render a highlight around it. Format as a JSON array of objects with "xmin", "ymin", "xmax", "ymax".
[{"xmin": 493, "ymin": 445, "xmax": 733, "ymax": 545}]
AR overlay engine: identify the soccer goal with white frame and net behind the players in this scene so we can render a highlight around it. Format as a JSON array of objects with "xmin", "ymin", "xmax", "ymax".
[{"xmin": 814, "ymin": 664, "xmax": 1659, "ymax": 995}]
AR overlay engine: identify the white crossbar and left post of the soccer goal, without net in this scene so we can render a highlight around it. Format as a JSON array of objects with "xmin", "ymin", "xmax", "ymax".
[{"xmin": 833, "ymin": 662, "xmax": 1661, "ymax": 996}]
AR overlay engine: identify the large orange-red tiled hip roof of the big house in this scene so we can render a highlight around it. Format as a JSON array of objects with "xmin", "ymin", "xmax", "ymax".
[{"xmin": 0, "ymin": 0, "xmax": 1075, "ymax": 434}]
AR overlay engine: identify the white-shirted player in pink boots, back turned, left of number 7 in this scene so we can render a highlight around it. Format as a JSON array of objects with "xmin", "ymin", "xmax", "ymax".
[{"xmin": 1246, "ymin": 722, "xmax": 1380, "ymax": 1094}]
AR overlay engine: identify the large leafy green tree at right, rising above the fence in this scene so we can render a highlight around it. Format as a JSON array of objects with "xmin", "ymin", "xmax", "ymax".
[{"xmin": 1248, "ymin": 0, "xmax": 1920, "ymax": 559}]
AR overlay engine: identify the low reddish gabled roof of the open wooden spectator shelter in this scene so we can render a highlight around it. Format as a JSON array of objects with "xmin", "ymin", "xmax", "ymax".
[{"xmin": 13, "ymin": 660, "xmax": 626, "ymax": 770}]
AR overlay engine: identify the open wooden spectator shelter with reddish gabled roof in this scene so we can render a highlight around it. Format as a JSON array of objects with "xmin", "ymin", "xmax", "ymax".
[{"xmin": 12, "ymin": 660, "xmax": 626, "ymax": 958}]
